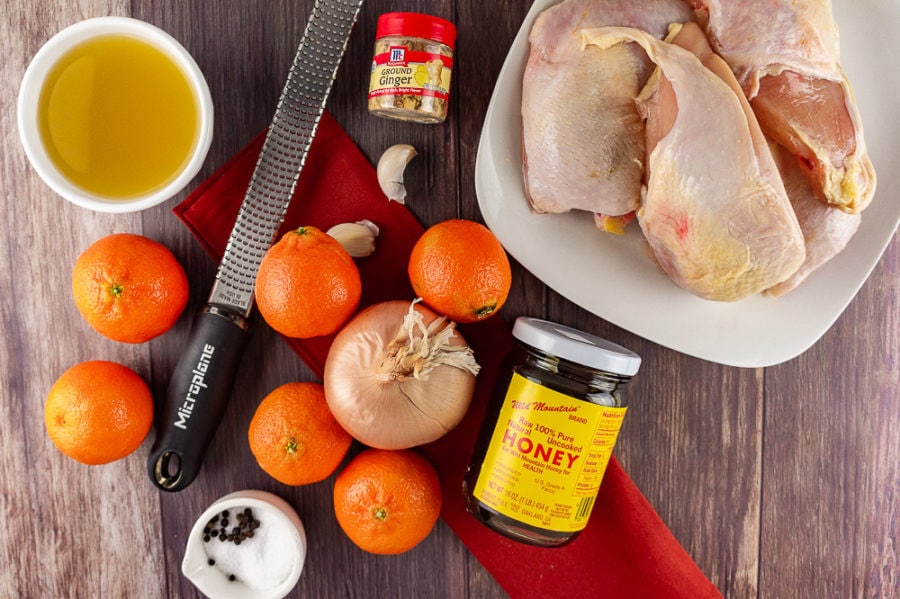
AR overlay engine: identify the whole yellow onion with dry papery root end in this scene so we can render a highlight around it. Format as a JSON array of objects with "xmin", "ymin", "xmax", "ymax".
[{"xmin": 324, "ymin": 300, "xmax": 479, "ymax": 449}]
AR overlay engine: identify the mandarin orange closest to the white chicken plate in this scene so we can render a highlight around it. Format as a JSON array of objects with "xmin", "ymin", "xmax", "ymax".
[{"xmin": 408, "ymin": 219, "xmax": 512, "ymax": 323}]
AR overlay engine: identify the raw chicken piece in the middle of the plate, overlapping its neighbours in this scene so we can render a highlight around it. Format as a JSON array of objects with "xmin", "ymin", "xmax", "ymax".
[{"xmin": 583, "ymin": 23, "xmax": 805, "ymax": 301}]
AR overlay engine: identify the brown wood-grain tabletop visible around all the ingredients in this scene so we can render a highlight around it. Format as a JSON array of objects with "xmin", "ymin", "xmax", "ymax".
[{"xmin": 0, "ymin": 0, "xmax": 900, "ymax": 598}]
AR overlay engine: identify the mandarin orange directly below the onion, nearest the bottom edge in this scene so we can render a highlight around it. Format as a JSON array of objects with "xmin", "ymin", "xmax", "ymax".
[{"xmin": 334, "ymin": 449, "xmax": 442, "ymax": 555}]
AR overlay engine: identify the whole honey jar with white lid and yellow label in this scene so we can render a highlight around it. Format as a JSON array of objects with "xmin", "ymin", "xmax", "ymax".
[{"xmin": 463, "ymin": 317, "xmax": 641, "ymax": 547}]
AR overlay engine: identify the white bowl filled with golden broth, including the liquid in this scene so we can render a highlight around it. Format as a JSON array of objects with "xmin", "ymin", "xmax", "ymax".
[{"xmin": 18, "ymin": 17, "xmax": 213, "ymax": 212}]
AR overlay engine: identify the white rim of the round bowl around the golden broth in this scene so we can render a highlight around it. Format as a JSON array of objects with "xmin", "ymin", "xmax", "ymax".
[{"xmin": 18, "ymin": 17, "xmax": 213, "ymax": 212}]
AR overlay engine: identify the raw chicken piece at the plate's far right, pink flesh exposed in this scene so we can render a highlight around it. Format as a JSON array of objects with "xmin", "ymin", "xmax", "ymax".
[{"xmin": 688, "ymin": 0, "xmax": 876, "ymax": 212}]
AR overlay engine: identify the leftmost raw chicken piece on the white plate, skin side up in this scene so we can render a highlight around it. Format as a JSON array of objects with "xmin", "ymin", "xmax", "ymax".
[{"xmin": 522, "ymin": 0, "xmax": 693, "ymax": 216}]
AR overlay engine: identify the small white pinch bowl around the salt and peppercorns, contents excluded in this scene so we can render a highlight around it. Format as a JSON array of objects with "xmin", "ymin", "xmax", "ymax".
[{"xmin": 181, "ymin": 490, "xmax": 306, "ymax": 599}]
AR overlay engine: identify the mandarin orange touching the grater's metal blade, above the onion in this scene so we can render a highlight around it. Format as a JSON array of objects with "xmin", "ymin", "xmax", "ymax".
[{"xmin": 256, "ymin": 227, "xmax": 362, "ymax": 339}]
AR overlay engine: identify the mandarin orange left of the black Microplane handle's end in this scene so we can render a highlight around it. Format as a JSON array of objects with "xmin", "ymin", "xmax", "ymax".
[{"xmin": 44, "ymin": 360, "xmax": 153, "ymax": 465}]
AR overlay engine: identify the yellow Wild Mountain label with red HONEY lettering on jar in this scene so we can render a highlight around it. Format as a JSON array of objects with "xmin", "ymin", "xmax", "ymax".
[{"xmin": 473, "ymin": 373, "xmax": 627, "ymax": 532}]
